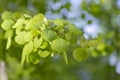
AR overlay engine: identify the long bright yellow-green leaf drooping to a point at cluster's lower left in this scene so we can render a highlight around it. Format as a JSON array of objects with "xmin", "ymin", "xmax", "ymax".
[{"xmin": 21, "ymin": 41, "xmax": 34, "ymax": 65}]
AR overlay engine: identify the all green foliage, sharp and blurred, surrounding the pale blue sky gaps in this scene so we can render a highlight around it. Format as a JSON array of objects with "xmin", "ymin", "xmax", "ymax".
[{"xmin": 0, "ymin": 0, "xmax": 120, "ymax": 80}]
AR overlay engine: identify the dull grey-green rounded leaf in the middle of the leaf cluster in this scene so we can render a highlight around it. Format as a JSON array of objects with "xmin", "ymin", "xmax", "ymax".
[{"xmin": 41, "ymin": 30, "xmax": 57, "ymax": 41}]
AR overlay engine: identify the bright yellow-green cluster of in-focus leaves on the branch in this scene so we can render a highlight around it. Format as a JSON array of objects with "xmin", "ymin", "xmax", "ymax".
[{"xmin": 1, "ymin": 11, "xmax": 98, "ymax": 65}]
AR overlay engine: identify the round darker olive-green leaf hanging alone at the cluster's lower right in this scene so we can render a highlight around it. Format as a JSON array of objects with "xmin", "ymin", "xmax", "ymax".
[{"xmin": 73, "ymin": 48, "xmax": 88, "ymax": 62}]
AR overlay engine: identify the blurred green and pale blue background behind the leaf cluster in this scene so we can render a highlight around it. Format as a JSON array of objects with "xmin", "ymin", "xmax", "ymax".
[{"xmin": 0, "ymin": 0, "xmax": 120, "ymax": 80}]
